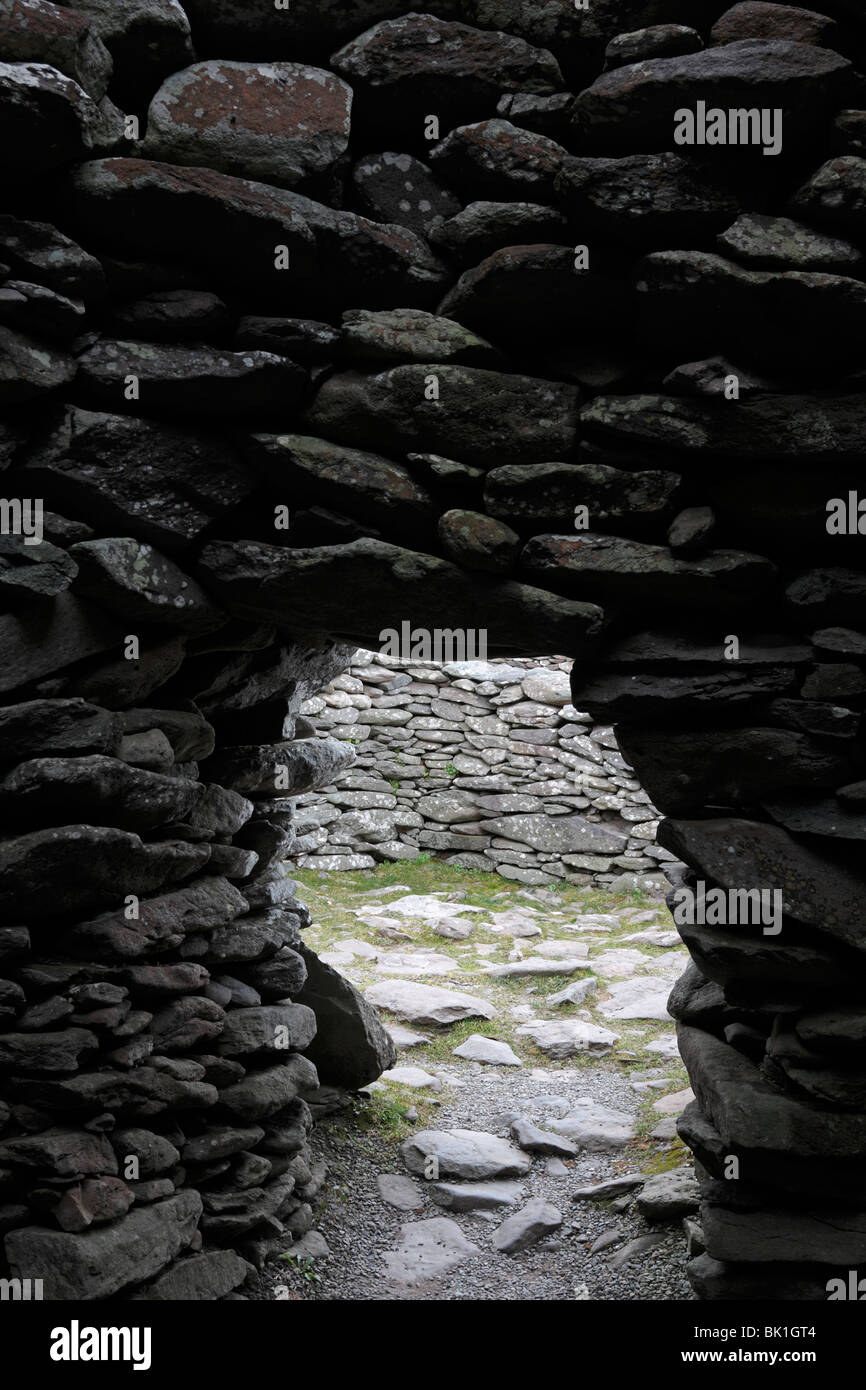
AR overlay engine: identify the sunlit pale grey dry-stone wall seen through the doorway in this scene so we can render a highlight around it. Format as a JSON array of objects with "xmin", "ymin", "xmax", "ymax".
[{"xmin": 292, "ymin": 651, "xmax": 674, "ymax": 894}]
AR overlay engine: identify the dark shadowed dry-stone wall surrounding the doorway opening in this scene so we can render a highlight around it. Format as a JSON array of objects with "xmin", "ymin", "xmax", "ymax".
[{"xmin": 0, "ymin": 0, "xmax": 866, "ymax": 1298}]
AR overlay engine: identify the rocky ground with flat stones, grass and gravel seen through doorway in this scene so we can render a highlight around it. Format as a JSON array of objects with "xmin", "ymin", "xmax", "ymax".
[{"xmin": 264, "ymin": 862, "xmax": 701, "ymax": 1301}]
